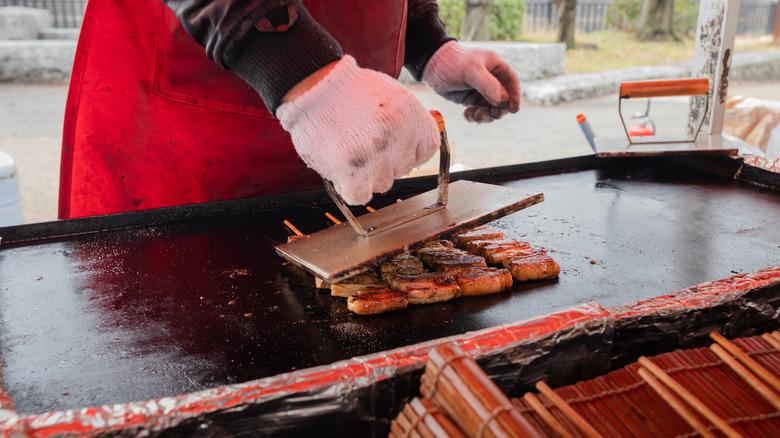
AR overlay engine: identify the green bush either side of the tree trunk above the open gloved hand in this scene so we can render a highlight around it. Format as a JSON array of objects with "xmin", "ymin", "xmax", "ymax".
[{"xmin": 438, "ymin": 0, "xmax": 525, "ymax": 41}]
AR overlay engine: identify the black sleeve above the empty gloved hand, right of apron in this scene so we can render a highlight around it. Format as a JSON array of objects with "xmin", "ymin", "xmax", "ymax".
[{"xmin": 404, "ymin": 0, "xmax": 455, "ymax": 81}]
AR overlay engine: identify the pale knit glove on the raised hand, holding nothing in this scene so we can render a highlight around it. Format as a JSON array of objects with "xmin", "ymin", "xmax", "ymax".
[{"xmin": 422, "ymin": 41, "xmax": 520, "ymax": 123}]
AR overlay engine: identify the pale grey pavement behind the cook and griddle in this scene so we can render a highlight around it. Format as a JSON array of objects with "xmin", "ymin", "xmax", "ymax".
[{"xmin": 0, "ymin": 82, "xmax": 780, "ymax": 222}]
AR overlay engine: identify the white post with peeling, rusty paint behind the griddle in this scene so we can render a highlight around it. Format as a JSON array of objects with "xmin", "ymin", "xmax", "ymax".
[{"xmin": 688, "ymin": 0, "xmax": 739, "ymax": 135}]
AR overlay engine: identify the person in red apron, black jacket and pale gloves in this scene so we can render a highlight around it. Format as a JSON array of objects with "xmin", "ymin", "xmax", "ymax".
[{"xmin": 59, "ymin": 0, "xmax": 520, "ymax": 218}]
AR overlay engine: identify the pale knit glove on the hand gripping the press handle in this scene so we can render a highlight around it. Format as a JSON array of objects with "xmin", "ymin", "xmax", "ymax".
[{"xmin": 276, "ymin": 55, "xmax": 441, "ymax": 205}]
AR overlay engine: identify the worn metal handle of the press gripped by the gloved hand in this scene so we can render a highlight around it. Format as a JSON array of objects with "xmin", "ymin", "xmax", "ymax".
[{"xmin": 324, "ymin": 111, "xmax": 450, "ymax": 237}]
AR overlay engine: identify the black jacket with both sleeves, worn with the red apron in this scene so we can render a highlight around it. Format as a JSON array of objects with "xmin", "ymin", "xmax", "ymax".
[{"xmin": 162, "ymin": 0, "xmax": 453, "ymax": 113}]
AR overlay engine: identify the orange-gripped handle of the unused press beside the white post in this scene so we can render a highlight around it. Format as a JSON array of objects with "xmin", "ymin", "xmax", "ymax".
[{"xmin": 618, "ymin": 78, "xmax": 710, "ymax": 145}]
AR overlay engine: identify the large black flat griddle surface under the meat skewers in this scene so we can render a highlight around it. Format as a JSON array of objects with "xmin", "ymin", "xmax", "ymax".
[{"xmin": 0, "ymin": 156, "xmax": 780, "ymax": 414}]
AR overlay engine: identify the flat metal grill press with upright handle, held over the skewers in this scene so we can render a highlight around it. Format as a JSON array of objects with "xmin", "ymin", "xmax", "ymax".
[{"xmin": 276, "ymin": 111, "xmax": 544, "ymax": 283}]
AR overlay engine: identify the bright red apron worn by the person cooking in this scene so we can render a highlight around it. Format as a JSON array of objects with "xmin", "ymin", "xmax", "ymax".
[{"xmin": 59, "ymin": 0, "xmax": 406, "ymax": 219}]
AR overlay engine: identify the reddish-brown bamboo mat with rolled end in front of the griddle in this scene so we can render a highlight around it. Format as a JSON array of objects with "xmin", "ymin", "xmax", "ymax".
[{"xmin": 391, "ymin": 332, "xmax": 780, "ymax": 438}]
